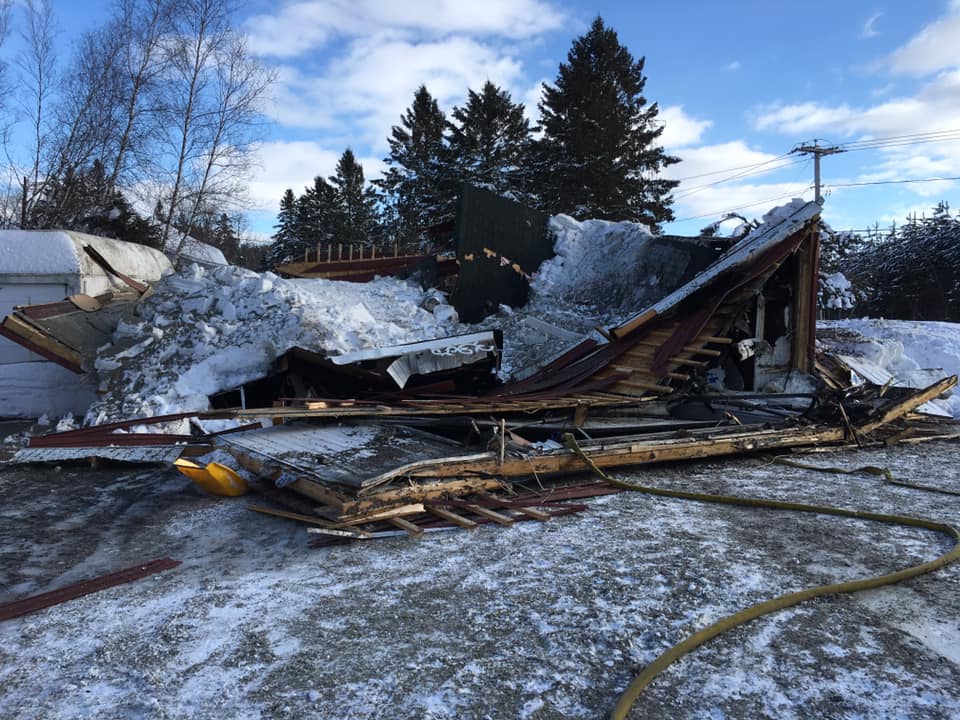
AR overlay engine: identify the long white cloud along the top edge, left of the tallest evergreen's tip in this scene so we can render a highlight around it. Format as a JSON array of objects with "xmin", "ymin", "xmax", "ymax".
[{"xmin": 246, "ymin": 0, "xmax": 566, "ymax": 58}]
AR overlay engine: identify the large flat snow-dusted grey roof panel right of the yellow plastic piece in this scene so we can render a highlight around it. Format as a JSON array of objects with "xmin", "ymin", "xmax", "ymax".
[{"xmin": 221, "ymin": 423, "xmax": 468, "ymax": 490}]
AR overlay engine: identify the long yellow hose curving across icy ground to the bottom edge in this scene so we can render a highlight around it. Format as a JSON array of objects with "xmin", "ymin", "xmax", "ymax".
[{"xmin": 564, "ymin": 434, "xmax": 960, "ymax": 720}]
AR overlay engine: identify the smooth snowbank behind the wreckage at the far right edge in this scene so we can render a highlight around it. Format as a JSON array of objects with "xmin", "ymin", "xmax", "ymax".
[{"xmin": 817, "ymin": 319, "xmax": 960, "ymax": 418}]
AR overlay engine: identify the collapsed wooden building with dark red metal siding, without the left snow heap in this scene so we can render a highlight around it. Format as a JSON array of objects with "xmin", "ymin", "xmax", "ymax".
[{"xmin": 4, "ymin": 189, "xmax": 956, "ymax": 542}]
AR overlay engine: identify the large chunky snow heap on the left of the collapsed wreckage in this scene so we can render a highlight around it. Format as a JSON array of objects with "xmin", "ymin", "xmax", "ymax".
[{"xmin": 86, "ymin": 265, "xmax": 461, "ymax": 424}]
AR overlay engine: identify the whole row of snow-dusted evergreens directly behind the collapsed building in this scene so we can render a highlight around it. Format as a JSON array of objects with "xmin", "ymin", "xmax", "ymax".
[{"xmin": 269, "ymin": 17, "xmax": 679, "ymax": 263}]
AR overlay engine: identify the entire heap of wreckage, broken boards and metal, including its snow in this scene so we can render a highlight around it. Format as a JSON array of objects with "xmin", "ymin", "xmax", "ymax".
[{"xmin": 3, "ymin": 201, "xmax": 957, "ymax": 543}]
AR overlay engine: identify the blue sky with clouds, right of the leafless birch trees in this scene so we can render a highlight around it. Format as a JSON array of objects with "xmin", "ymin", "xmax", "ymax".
[{"xmin": 39, "ymin": 0, "xmax": 960, "ymax": 239}]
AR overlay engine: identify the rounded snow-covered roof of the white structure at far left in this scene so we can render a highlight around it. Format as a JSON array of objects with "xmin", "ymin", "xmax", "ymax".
[{"xmin": 0, "ymin": 230, "xmax": 172, "ymax": 280}]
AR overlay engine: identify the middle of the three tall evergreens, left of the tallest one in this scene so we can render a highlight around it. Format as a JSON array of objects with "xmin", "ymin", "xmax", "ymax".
[{"xmin": 447, "ymin": 80, "xmax": 531, "ymax": 199}]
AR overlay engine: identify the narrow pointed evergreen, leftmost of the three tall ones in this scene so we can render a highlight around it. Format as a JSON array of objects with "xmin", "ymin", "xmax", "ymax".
[{"xmin": 377, "ymin": 85, "xmax": 456, "ymax": 241}]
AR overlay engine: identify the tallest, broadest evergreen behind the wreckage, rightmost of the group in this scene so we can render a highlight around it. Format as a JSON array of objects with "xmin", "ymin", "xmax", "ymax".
[{"xmin": 537, "ymin": 17, "xmax": 679, "ymax": 227}]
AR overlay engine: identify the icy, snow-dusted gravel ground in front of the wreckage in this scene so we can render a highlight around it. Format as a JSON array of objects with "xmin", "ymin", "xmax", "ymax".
[{"xmin": 0, "ymin": 442, "xmax": 960, "ymax": 720}]
